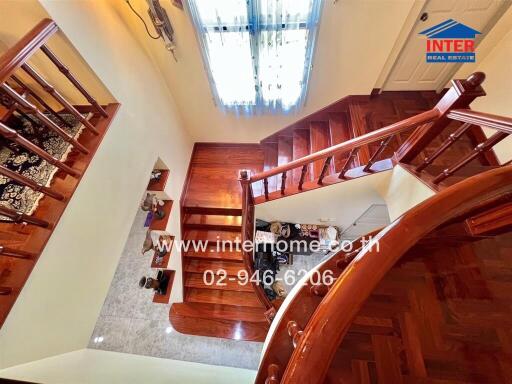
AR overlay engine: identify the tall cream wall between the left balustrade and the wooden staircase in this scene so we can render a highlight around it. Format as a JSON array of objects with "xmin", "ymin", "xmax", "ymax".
[{"xmin": 0, "ymin": 0, "xmax": 192, "ymax": 367}]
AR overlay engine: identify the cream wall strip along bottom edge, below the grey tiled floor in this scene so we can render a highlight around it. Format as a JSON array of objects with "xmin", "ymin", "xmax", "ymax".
[{"xmin": 0, "ymin": 349, "xmax": 256, "ymax": 384}]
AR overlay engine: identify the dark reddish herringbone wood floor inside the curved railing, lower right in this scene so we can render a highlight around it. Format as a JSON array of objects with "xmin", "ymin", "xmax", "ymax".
[{"xmin": 326, "ymin": 234, "xmax": 512, "ymax": 384}]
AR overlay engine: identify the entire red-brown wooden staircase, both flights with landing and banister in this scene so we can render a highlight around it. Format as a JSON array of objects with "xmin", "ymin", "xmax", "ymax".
[{"xmin": 170, "ymin": 74, "xmax": 512, "ymax": 340}]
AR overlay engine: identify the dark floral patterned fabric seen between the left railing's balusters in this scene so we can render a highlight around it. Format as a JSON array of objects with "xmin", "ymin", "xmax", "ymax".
[{"xmin": 0, "ymin": 114, "xmax": 87, "ymax": 221}]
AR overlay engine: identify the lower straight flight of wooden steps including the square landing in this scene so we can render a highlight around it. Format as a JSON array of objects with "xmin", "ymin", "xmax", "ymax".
[{"xmin": 169, "ymin": 144, "xmax": 269, "ymax": 341}]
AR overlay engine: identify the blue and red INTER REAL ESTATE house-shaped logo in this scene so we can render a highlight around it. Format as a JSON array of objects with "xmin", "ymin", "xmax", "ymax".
[{"xmin": 420, "ymin": 19, "xmax": 480, "ymax": 63}]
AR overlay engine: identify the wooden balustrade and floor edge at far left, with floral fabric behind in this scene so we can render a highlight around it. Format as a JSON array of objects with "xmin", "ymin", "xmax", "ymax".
[{"xmin": 0, "ymin": 19, "xmax": 119, "ymax": 325}]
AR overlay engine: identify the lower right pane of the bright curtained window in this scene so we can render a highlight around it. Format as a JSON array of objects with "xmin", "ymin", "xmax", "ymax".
[{"xmin": 259, "ymin": 29, "xmax": 308, "ymax": 108}]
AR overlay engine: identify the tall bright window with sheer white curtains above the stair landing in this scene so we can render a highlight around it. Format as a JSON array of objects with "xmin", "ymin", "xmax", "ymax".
[{"xmin": 188, "ymin": 0, "xmax": 322, "ymax": 113}]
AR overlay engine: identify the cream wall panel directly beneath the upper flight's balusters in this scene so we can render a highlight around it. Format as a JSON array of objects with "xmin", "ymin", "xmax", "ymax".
[{"xmin": 256, "ymin": 171, "xmax": 391, "ymax": 230}]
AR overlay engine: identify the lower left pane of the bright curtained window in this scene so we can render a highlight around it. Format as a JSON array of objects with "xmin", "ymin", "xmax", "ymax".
[{"xmin": 205, "ymin": 32, "xmax": 256, "ymax": 105}]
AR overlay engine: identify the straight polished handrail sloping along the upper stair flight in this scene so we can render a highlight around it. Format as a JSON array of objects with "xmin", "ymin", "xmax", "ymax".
[{"xmin": 250, "ymin": 109, "xmax": 439, "ymax": 183}]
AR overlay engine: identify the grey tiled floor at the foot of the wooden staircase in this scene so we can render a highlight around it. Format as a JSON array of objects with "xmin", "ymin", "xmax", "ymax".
[{"xmin": 89, "ymin": 211, "xmax": 263, "ymax": 369}]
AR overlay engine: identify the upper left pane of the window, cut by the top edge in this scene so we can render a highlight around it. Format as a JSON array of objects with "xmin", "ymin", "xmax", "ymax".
[{"xmin": 195, "ymin": 0, "xmax": 247, "ymax": 26}]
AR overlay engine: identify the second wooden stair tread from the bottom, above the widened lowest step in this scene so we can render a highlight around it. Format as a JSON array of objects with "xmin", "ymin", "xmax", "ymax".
[{"xmin": 184, "ymin": 288, "xmax": 264, "ymax": 308}]
